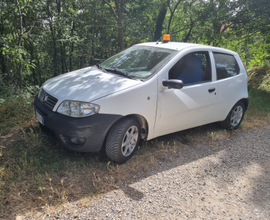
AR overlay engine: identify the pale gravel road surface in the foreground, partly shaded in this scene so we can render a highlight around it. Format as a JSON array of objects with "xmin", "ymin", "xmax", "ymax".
[{"xmin": 22, "ymin": 125, "xmax": 270, "ymax": 220}]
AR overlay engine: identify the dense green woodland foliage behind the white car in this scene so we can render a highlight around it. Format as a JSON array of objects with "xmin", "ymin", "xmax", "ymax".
[{"xmin": 0, "ymin": 0, "xmax": 270, "ymax": 88}]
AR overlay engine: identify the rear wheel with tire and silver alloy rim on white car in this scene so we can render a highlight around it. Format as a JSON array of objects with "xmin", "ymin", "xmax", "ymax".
[{"xmin": 220, "ymin": 101, "xmax": 246, "ymax": 130}]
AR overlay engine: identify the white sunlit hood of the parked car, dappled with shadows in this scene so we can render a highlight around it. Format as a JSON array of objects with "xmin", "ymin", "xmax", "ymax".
[{"xmin": 43, "ymin": 67, "xmax": 142, "ymax": 102}]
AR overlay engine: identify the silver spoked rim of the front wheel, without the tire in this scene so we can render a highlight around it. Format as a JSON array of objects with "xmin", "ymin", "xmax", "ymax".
[{"xmin": 121, "ymin": 125, "xmax": 139, "ymax": 157}]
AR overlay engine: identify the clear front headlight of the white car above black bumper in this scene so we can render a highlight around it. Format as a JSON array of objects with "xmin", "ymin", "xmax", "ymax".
[{"xmin": 57, "ymin": 101, "xmax": 100, "ymax": 117}]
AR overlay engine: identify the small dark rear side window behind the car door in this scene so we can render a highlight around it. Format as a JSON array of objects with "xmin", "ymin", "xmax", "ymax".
[{"xmin": 213, "ymin": 53, "xmax": 240, "ymax": 80}]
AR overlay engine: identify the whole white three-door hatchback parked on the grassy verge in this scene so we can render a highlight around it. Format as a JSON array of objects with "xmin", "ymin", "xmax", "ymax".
[{"xmin": 34, "ymin": 35, "xmax": 249, "ymax": 163}]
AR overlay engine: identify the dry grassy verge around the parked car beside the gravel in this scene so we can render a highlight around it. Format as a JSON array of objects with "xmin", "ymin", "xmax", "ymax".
[{"xmin": 0, "ymin": 69, "xmax": 270, "ymax": 219}]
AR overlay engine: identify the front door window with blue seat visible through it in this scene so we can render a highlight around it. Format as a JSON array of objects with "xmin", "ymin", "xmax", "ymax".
[{"xmin": 169, "ymin": 51, "xmax": 212, "ymax": 85}]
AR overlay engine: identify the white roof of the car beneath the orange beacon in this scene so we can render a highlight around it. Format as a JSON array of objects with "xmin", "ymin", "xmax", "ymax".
[{"xmin": 136, "ymin": 42, "xmax": 236, "ymax": 54}]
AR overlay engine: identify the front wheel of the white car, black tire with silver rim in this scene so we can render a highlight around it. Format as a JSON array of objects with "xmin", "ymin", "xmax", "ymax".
[{"xmin": 105, "ymin": 118, "xmax": 141, "ymax": 163}]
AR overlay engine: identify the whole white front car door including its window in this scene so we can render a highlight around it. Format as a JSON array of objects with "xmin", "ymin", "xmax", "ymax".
[{"xmin": 155, "ymin": 51, "xmax": 218, "ymax": 136}]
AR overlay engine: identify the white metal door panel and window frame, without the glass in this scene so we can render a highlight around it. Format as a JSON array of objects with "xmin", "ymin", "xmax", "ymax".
[{"xmin": 155, "ymin": 46, "xmax": 218, "ymax": 137}]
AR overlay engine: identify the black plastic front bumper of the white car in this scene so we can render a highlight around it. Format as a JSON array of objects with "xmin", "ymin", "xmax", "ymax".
[{"xmin": 34, "ymin": 96, "xmax": 122, "ymax": 152}]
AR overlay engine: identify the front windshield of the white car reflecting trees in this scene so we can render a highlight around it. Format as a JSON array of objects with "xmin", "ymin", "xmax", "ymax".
[{"xmin": 100, "ymin": 46, "xmax": 177, "ymax": 79}]
